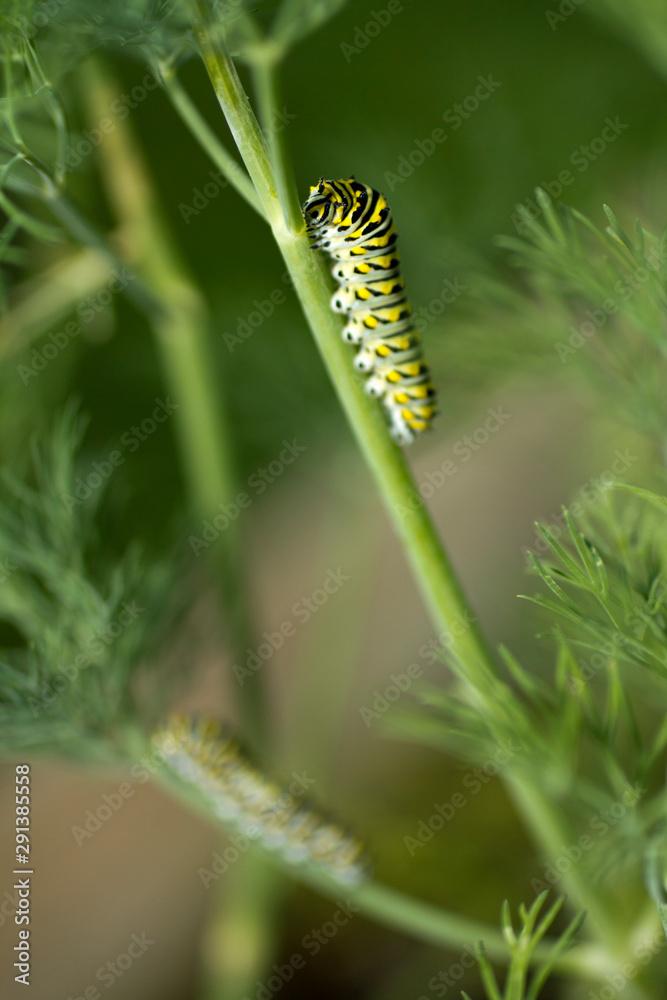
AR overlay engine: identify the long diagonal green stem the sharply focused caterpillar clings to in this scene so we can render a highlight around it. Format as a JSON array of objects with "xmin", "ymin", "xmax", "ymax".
[{"xmin": 183, "ymin": 2, "xmax": 648, "ymax": 951}]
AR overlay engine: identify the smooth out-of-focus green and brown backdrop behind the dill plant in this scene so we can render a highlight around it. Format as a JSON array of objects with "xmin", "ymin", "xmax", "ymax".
[{"xmin": 0, "ymin": 0, "xmax": 667, "ymax": 1000}]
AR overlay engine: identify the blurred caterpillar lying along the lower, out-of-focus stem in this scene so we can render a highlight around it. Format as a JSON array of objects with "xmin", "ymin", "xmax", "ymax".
[{"xmin": 152, "ymin": 715, "xmax": 370, "ymax": 885}]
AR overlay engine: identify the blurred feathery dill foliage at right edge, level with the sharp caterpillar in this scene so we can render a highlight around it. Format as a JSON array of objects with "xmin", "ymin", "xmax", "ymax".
[{"xmin": 454, "ymin": 188, "xmax": 667, "ymax": 422}]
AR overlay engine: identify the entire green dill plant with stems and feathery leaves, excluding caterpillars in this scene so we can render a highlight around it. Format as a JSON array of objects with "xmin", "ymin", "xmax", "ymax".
[{"xmin": 0, "ymin": 0, "xmax": 667, "ymax": 1000}]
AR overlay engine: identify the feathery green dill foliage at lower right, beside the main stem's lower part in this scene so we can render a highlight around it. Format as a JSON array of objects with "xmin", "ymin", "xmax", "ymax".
[{"xmin": 390, "ymin": 476, "xmax": 667, "ymax": 907}]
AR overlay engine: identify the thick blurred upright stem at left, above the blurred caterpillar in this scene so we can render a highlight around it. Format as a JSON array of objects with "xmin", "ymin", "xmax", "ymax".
[{"xmin": 82, "ymin": 56, "xmax": 266, "ymax": 751}]
